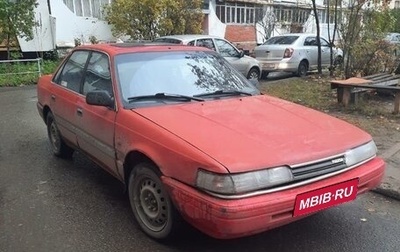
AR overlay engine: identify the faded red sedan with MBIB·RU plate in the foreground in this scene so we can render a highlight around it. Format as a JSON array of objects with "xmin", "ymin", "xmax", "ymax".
[{"xmin": 37, "ymin": 44, "xmax": 385, "ymax": 239}]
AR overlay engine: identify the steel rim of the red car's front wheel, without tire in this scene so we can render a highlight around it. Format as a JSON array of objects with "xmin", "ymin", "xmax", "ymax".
[{"xmin": 134, "ymin": 177, "xmax": 168, "ymax": 232}]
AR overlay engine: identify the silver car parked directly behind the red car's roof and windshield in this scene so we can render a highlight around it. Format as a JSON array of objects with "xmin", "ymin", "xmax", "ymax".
[{"xmin": 155, "ymin": 35, "xmax": 261, "ymax": 80}]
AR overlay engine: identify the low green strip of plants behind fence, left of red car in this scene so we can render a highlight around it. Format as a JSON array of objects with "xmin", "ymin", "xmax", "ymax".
[{"xmin": 0, "ymin": 60, "xmax": 59, "ymax": 87}]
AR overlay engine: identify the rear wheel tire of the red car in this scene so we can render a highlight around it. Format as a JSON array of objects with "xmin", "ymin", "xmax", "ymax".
[{"xmin": 46, "ymin": 112, "xmax": 74, "ymax": 159}]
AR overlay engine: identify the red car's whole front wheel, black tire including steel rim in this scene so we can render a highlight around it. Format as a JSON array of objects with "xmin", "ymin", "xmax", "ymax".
[{"xmin": 128, "ymin": 163, "xmax": 182, "ymax": 241}]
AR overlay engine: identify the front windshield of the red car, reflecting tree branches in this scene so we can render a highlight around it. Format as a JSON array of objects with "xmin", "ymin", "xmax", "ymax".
[{"xmin": 115, "ymin": 51, "xmax": 259, "ymax": 106}]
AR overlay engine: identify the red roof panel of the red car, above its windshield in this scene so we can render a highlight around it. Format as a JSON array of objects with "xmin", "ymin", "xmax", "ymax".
[{"xmin": 74, "ymin": 42, "xmax": 211, "ymax": 55}]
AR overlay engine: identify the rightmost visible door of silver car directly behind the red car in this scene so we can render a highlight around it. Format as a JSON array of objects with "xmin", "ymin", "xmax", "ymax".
[{"xmin": 215, "ymin": 39, "xmax": 248, "ymax": 76}]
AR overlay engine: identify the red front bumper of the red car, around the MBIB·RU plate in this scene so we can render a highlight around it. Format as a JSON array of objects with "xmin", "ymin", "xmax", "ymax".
[{"xmin": 162, "ymin": 158, "xmax": 385, "ymax": 239}]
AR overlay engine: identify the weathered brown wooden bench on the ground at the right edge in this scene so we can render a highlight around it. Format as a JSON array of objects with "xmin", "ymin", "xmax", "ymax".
[{"xmin": 331, "ymin": 78, "xmax": 400, "ymax": 114}]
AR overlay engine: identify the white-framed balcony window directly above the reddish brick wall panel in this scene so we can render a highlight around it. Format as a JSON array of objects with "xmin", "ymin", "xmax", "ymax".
[{"xmin": 216, "ymin": 3, "xmax": 263, "ymax": 24}]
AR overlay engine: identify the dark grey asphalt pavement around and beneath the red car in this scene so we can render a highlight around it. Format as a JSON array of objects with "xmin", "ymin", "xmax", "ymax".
[{"xmin": 0, "ymin": 87, "xmax": 400, "ymax": 252}]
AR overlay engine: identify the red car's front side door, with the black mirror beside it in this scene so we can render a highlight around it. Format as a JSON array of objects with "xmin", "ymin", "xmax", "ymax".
[{"xmin": 75, "ymin": 51, "xmax": 118, "ymax": 177}]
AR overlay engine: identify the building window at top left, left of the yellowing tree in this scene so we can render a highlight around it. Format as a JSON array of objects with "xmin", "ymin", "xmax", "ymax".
[{"xmin": 63, "ymin": 0, "xmax": 113, "ymax": 19}]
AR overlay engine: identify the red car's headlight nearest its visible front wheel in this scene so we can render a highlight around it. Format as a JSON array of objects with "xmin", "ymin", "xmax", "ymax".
[{"xmin": 196, "ymin": 166, "xmax": 293, "ymax": 194}]
